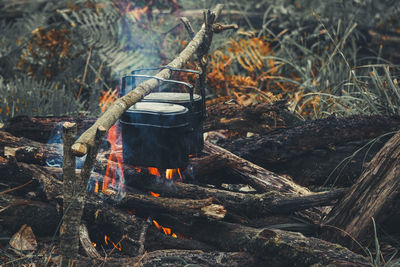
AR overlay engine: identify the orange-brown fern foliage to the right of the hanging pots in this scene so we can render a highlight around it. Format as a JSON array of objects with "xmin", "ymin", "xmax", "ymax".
[{"xmin": 207, "ymin": 37, "xmax": 290, "ymax": 105}]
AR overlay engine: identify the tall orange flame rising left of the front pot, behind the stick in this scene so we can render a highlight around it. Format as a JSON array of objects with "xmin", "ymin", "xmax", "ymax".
[{"xmin": 94, "ymin": 88, "xmax": 124, "ymax": 193}]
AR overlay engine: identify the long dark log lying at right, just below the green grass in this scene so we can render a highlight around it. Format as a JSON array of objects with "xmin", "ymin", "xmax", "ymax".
[{"xmin": 220, "ymin": 115, "xmax": 400, "ymax": 166}]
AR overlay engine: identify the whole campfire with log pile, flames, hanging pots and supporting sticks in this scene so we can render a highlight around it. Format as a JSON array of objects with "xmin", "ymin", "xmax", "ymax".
[{"xmin": 0, "ymin": 2, "xmax": 400, "ymax": 266}]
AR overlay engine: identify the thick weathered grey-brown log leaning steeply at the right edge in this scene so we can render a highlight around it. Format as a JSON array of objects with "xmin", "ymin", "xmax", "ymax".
[{"xmin": 324, "ymin": 133, "xmax": 400, "ymax": 246}]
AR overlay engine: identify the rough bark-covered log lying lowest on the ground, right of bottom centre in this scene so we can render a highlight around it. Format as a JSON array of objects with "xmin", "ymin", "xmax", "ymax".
[{"xmin": 182, "ymin": 220, "xmax": 370, "ymax": 266}]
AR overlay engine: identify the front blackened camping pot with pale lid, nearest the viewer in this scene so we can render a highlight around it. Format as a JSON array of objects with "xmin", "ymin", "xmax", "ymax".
[{"xmin": 120, "ymin": 102, "xmax": 191, "ymax": 169}]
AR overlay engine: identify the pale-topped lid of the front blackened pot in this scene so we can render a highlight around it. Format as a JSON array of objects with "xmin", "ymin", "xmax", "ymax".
[{"xmin": 121, "ymin": 102, "xmax": 189, "ymax": 128}]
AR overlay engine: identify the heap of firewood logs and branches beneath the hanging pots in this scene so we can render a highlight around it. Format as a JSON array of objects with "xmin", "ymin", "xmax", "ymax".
[{"xmin": 0, "ymin": 108, "xmax": 400, "ymax": 266}]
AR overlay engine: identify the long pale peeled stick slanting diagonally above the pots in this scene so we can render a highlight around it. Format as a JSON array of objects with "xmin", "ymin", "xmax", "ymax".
[{"xmin": 72, "ymin": 5, "xmax": 222, "ymax": 156}]
